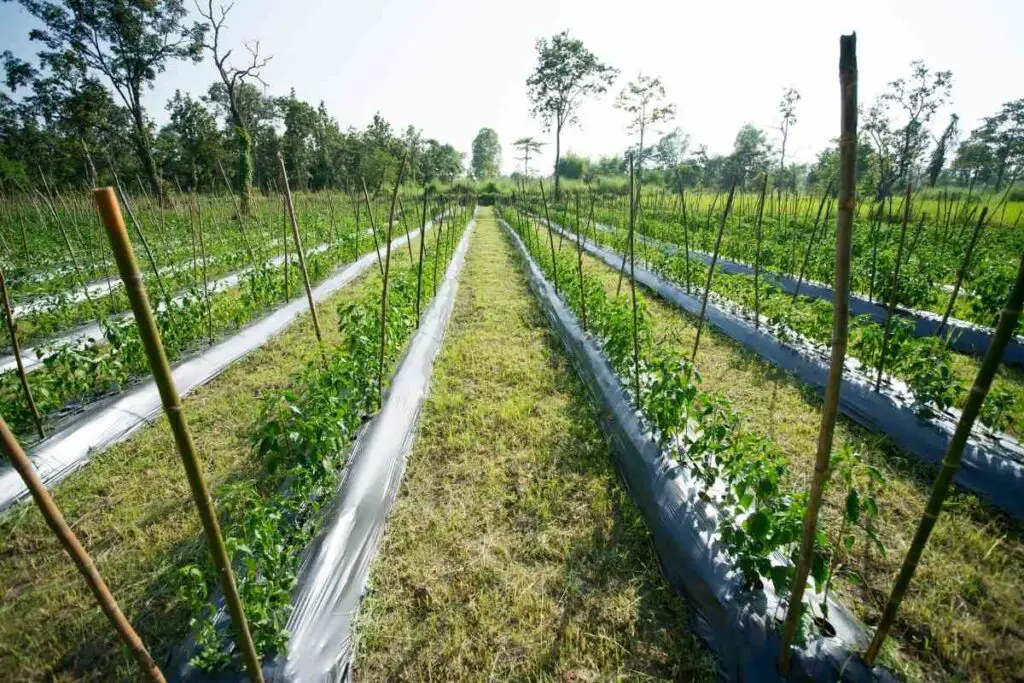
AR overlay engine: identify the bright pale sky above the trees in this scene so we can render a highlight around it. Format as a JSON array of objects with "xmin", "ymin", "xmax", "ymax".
[{"xmin": 0, "ymin": 0, "xmax": 1024, "ymax": 172}]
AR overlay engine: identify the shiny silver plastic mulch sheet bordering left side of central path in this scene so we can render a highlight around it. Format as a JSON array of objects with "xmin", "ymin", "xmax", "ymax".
[{"xmin": 171, "ymin": 215, "xmax": 474, "ymax": 683}]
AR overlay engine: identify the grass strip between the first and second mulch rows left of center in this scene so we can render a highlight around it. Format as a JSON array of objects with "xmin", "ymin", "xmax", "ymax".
[{"xmin": 0, "ymin": 233, "xmax": 423, "ymax": 681}]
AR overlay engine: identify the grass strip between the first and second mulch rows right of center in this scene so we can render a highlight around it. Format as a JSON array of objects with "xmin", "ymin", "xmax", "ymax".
[{"xmin": 542, "ymin": 218, "xmax": 1024, "ymax": 681}]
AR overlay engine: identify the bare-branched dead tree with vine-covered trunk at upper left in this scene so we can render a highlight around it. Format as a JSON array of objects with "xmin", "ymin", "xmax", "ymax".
[{"xmin": 196, "ymin": 0, "xmax": 271, "ymax": 215}]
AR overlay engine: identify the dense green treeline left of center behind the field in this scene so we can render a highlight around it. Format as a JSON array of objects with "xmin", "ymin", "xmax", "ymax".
[{"xmin": 0, "ymin": 0, "xmax": 463, "ymax": 199}]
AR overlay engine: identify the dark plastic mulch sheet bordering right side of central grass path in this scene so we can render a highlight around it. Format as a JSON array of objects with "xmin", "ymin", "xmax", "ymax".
[{"xmin": 505, "ymin": 219, "xmax": 894, "ymax": 681}]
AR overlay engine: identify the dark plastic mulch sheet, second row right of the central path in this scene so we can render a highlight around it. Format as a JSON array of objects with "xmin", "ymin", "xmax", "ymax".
[{"xmin": 536, "ymin": 219, "xmax": 1024, "ymax": 520}]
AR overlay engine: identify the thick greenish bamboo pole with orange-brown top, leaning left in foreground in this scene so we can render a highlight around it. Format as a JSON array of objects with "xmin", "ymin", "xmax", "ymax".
[{"xmin": 93, "ymin": 187, "xmax": 263, "ymax": 683}]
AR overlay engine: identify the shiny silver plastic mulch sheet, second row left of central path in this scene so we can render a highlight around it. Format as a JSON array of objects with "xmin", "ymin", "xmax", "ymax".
[{"xmin": 0, "ymin": 223, "xmax": 442, "ymax": 511}]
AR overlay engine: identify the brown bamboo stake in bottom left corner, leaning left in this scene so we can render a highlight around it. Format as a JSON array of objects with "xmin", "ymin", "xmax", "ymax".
[{"xmin": 0, "ymin": 418, "xmax": 164, "ymax": 683}]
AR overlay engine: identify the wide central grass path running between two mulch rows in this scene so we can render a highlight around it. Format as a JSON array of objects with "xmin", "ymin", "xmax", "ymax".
[{"xmin": 356, "ymin": 210, "xmax": 711, "ymax": 681}]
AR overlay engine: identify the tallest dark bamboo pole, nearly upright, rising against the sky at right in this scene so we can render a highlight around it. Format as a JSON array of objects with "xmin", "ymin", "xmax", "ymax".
[{"xmin": 779, "ymin": 33, "xmax": 857, "ymax": 675}]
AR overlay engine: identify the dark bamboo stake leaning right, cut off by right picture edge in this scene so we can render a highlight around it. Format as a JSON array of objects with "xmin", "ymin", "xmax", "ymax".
[{"xmin": 864, "ymin": 249, "xmax": 1024, "ymax": 666}]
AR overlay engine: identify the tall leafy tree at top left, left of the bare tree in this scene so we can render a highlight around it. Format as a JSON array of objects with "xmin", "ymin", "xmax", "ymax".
[{"xmin": 18, "ymin": 0, "xmax": 203, "ymax": 196}]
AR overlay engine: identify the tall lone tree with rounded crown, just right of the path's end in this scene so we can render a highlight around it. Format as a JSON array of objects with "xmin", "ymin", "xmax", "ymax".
[{"xmin": 526, "ymin": 31, "xmax": 618, "ymax": 201}]
